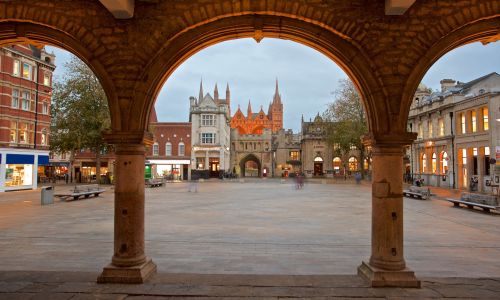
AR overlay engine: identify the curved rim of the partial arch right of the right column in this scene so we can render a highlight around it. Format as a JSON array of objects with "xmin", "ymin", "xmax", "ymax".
[{"xmin": 400, "ymin": 17, "xmax": 500, "ymax": 126}]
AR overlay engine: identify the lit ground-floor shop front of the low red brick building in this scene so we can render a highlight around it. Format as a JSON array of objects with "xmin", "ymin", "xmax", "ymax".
[{"xmin": 146, "ymin": 159, "xmax": 190, "ymax": 181}]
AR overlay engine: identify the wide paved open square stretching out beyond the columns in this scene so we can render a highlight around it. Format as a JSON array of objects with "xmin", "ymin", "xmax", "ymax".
[{"xmin": 0, "ymin": 179, "xmax": 500, "ymax": 298}]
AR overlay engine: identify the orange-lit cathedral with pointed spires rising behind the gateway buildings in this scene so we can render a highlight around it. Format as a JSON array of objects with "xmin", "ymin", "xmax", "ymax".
[{"xmin": 230, "ymin": 79, "xmax": 283, "ymax": 135}]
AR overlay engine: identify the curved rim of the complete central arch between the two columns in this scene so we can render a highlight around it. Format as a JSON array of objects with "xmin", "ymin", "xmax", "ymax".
[{"xmin": 134, "ymin": 15, "xmax": 390, "ymax": 132}]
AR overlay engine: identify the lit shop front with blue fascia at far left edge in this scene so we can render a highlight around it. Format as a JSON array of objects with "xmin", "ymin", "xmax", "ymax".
[{"xmin": 0, "ymin": 149, "xmax": 49, "ymax": 192}]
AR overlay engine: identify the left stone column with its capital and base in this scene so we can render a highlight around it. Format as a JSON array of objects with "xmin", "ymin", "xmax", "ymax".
[{"xmin": 97, "ymin": 133, "xmax": 156, "ymax": 283}]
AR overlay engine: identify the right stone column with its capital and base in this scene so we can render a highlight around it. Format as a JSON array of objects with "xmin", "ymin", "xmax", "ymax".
[{"xmin": 358, "ymin": 133, "xmax": 420, "ymax": 287}]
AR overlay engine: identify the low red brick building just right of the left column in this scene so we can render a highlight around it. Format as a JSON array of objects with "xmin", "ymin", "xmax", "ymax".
[{"xmin": 146, "ymin": 109, "xmax": 191, "ymax": 180}]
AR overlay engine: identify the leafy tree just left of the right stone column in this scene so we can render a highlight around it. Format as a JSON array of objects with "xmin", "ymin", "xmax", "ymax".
[{"xmin": 323, "ymin": 79, "xmax": 368, "ymax": 177}]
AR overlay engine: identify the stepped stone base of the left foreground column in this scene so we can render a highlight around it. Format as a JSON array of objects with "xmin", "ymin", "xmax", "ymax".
[{"xmin": 97, "ymin": 258, "xmax": 156, "ymax": 283}]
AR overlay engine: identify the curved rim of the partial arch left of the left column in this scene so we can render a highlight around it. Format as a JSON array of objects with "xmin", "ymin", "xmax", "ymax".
[{"xmin": 0, "ymin": 21, "xmax": 120, "ymax": 129}]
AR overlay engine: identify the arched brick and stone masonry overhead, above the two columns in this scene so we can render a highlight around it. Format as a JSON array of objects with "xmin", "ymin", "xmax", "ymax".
[{"xmin": 0, "ymin": 0, "xmax": 500, "ymax": 144}]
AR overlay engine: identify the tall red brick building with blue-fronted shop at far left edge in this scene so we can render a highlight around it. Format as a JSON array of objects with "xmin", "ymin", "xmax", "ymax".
[{"xmin": 0, "ymin": 45, "xmax": 55, "ymax": 191}]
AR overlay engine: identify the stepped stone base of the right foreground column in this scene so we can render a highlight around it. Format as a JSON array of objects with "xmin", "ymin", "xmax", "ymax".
[{"xmin": 358, "ymin": 262, "xmax": 420, "ymax": 288}]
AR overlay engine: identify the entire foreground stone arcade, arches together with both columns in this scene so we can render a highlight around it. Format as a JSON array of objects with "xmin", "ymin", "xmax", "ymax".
[{"xmin": 0, "ymin": 0, "xmax": 500, "ymax": 287}]
